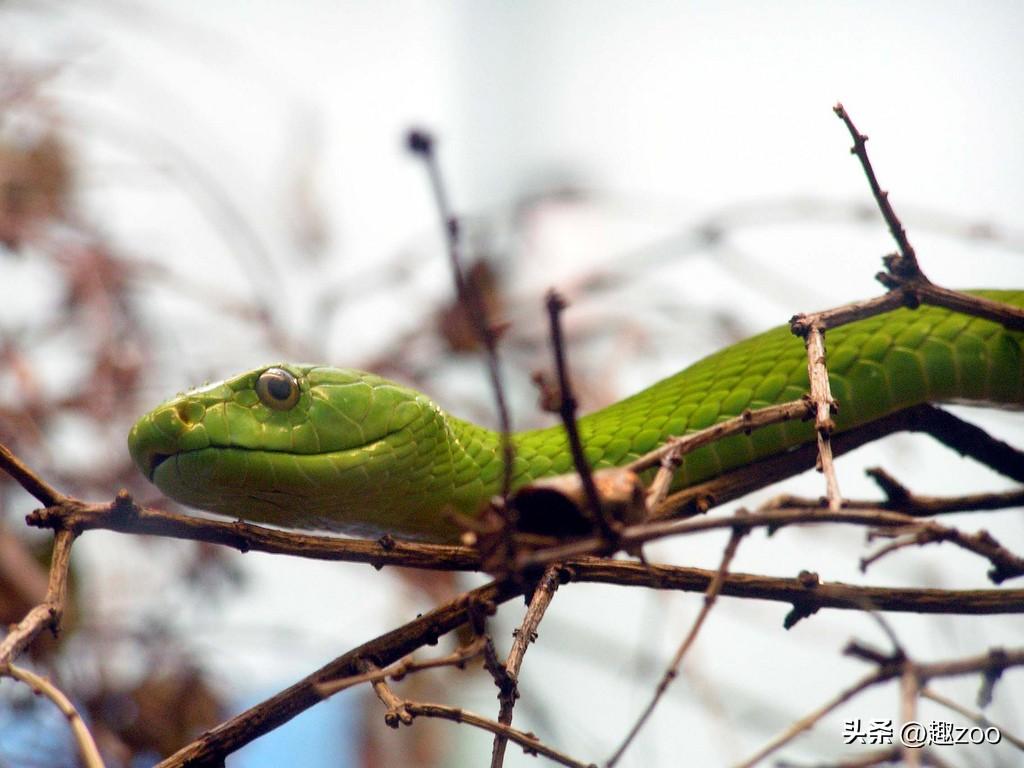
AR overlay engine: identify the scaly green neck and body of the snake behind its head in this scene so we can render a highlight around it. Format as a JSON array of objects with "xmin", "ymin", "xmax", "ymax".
[{"xmin": 447, "ymin": 291, "xmax": 1024, "ymax": 512}]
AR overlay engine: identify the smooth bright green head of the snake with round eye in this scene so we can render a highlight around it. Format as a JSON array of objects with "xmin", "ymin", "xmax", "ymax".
[{"xmin": 128, "ymin": 364, "xmax": 442, "ymax": 532}]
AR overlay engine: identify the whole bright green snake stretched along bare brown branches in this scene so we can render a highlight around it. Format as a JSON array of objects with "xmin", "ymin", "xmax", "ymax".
[{"xmin": 128, "ymin": 291, "xmax": 1024, "ymax": 541}]
